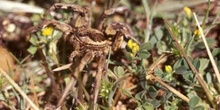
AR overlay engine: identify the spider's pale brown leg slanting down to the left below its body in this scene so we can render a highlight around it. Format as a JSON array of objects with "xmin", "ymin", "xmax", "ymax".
[{"xmin": 57, "ymin": 51, "xmax": 94, "ymax": 107}]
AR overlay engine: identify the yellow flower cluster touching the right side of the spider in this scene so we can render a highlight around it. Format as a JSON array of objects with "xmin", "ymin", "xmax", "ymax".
[{"xmin": 127, "ymin": 39, "xmax": 140, "ymax": 57}]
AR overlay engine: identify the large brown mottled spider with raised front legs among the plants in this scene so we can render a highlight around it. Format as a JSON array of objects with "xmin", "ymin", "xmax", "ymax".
[{"xmin": 29, "ymin": 3, "xmax": 136, "ymax": 109}]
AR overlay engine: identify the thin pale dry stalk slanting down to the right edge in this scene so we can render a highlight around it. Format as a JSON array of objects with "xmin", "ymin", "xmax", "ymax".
[{"xmin": 193, "ymin": 13, "xmax": 220, "ymax": 83}]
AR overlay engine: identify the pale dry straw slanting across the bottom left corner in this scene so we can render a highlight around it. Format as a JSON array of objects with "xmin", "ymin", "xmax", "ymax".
[{"xmin": 0, "ymin": 68, "xmax": 40, "ymax": 110}]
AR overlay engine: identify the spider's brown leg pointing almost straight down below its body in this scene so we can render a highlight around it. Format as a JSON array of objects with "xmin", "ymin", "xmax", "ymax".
[{"xmin": 93, "ymin": 54, "xmax": 106, "ymax": 110}]
